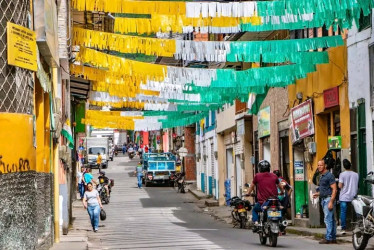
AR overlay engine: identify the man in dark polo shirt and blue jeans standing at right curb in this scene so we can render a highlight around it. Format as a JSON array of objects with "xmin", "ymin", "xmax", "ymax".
[{"xmin": 313, "ymin": 160, "xmax": 337, "ymax": 244}]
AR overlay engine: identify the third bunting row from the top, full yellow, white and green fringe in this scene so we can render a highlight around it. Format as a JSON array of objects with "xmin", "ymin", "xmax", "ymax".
[{"xmin": 74, "ymin": 29, "xmax": 344, "ymax": 63}]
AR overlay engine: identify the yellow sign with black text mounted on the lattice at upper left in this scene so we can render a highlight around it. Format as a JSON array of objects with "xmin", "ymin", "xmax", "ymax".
[{"xmin": 7, "ymin": 22, "xmax": 38, "ymax": 71}]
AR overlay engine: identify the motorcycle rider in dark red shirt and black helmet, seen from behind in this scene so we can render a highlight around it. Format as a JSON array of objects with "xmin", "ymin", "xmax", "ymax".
[{"xmin": 248, "ymin": 160, "xmax": 283, "ymax": 232}]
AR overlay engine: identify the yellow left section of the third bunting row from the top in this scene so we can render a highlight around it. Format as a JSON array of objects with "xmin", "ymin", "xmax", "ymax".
[{"xmin": 74, "ymin": 28, "xmax": 175, "ymax": 57}]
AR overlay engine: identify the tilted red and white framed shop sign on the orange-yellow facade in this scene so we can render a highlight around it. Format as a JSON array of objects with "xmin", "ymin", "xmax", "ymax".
[{"xmin": 291, "ymin": 100, "xmax": 314, "ymax": 142}]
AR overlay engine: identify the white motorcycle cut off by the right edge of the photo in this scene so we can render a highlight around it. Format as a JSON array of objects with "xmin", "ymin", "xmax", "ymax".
[{"xmin": 352, "ymin": 172, "xmax": 374, "ymax": 250}]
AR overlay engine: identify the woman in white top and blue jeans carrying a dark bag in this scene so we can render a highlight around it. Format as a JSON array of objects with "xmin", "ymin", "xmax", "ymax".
[{"xmin": 83, "ymin": 182, "xmax": 103, "ymax": 233}]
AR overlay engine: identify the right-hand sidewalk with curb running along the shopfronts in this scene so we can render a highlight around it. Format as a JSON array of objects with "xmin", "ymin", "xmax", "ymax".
[{"xmin": 189, "ymin": 189, "xmax": 352, "ymax": 243}]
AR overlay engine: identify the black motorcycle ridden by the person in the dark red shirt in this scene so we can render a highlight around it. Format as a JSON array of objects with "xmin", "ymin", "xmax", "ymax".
[{"xmin": 254, "ymin": 198, "xmax": 288, "ymax": 247}]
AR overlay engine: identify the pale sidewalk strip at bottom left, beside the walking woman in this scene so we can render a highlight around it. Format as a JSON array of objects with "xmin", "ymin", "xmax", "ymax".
[{"xmin": 51, "ymin": 200, "xmax": 91, "ymax": 250}]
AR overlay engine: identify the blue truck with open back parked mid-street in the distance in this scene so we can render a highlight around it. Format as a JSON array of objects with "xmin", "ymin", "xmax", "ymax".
[{"xmin": 143, "ymin": 153, "xmax": 176, "ymax": 187}]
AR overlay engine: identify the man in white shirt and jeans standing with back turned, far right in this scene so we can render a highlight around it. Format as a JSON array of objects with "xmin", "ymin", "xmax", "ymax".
[{"xmin": 338, "ymin": 159, "xmax": 358, "ymax": 234}]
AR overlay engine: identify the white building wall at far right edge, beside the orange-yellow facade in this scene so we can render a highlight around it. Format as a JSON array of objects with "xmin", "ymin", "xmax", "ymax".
[{"xmin": 347, "ymin": 15, "xmax": 374, "ymax": 171}]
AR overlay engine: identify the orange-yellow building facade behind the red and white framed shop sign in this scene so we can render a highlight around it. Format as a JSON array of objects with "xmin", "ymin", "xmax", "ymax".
[{"xmin": 288, "ymin": 46, "xmax": 350, "ymax": 182}]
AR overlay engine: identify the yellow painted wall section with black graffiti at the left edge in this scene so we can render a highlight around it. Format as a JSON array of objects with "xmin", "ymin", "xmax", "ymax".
[{"xmin": 0, "ymin": 113, "xmax": 36, "ymax": 175}]
